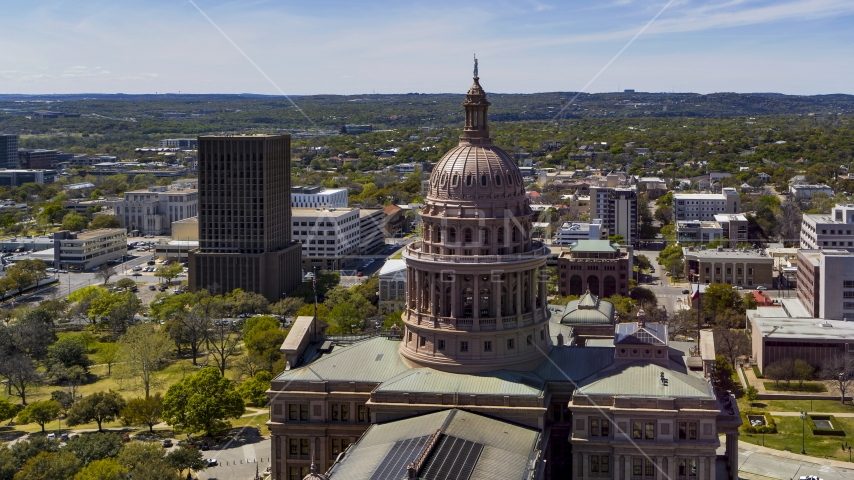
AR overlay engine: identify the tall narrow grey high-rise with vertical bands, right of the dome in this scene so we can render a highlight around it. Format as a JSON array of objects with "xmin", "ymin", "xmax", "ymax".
[{"xmin": 590, "ymin": 186, "xmax": 638, "ymax": 244}]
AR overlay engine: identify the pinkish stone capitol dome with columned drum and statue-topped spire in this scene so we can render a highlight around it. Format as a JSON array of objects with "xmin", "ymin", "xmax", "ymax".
[{"xmin": 400, "ymin": 64, "xmax": 552, "ymax": 373}]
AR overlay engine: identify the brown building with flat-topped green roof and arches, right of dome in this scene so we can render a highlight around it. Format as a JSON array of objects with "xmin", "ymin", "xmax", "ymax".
[{"xmin": 557, "ymin": 240, "xmax": 632, "ymax": 298}]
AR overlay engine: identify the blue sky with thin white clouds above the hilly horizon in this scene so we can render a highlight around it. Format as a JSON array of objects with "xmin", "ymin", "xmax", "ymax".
[{"xmin": 0, "ymin": 0, "xmax": 854, "ymax": 94}]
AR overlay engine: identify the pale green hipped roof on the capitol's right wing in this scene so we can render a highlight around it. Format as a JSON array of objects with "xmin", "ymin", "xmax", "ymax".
[{"xmin": 576, "ymin": 360, "xmax": 715, "ymax": 398}]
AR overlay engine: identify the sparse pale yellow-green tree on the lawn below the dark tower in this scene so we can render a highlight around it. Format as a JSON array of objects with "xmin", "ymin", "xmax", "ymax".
[{"xmin": 119, "ymin": 323, "xmax": 172, "ymax": 398}]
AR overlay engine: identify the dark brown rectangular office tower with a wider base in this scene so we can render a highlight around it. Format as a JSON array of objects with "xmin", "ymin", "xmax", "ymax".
[{"xmin": 189, "ymin": 135, "xmax": 301, "ymax": 302}]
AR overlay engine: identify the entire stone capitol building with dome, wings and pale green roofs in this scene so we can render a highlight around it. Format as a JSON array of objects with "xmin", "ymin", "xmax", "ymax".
[{"xmin": 267, "ymin": 67, "xmax": 741, "ymax": 480}]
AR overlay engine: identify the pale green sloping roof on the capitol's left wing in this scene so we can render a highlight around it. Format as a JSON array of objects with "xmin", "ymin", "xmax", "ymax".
[{"xmin": 274, "ymin": 337, "xmax": 412, "ymax": 383}]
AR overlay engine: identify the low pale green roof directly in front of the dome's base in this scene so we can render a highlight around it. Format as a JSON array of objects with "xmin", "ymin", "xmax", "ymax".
[{"xmin": 374, "ymin": 368, "xmax": 545, "ymax": 397}]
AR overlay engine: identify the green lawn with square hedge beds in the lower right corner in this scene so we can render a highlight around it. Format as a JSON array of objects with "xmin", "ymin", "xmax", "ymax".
[{"xmin": 738, "ymin": 417, "xmax": 854, "ymax": 461}]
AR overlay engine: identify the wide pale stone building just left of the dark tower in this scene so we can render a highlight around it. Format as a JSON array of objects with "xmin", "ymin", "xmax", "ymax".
[{"xmin": 113, "ymin": 186, "xmax": 199, "ymax": 235}]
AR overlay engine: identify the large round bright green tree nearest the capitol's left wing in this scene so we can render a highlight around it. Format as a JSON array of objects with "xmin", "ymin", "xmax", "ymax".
[{"xmin": 163, "ymin": 367, "xmax": 245, "ymax": 435}]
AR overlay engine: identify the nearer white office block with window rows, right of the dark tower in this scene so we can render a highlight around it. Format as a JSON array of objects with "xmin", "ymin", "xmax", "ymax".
[{"xmin": 291, "ymin": 208, "xmax": 361, "ymax": 272}]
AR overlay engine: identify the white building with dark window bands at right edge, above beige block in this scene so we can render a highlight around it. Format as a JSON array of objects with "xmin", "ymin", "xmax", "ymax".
[{"xmin": 801, "ymin": 203, "xmax": 854, "ymax": 250}]
